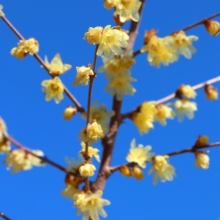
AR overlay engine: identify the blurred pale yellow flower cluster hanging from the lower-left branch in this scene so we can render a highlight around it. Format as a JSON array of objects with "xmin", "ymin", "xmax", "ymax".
[{"xmin": 5, "ymin": 149, "xmax": 44, "ymax": 173}]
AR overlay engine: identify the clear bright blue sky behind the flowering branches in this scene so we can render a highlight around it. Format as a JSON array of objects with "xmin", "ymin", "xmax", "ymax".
[{"xmin": 0, "ymin": 0, "xmax": 220, "ymax": 220}]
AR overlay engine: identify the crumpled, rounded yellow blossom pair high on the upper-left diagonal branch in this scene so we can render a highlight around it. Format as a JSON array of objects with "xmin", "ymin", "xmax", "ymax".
[{"xmin": 11, "ymin": 38, "xmax": 39, "ymax": 59}]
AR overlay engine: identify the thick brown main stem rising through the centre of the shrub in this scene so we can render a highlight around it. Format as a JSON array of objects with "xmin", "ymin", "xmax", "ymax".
[{"xmin": 91, "ymin": 0, "xmax": 145, "ymax": 191}]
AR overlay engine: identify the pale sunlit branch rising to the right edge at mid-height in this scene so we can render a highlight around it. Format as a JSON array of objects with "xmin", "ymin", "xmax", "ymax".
[{"xmin": 122, "ymin": 76, "xmax": 220, "ymax": 119}]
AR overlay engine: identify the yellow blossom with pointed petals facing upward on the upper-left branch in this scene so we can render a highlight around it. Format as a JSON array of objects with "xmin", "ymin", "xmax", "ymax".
[{"xmin": 45, "ymin": 53, "xmax": 72, "ymax": 75}]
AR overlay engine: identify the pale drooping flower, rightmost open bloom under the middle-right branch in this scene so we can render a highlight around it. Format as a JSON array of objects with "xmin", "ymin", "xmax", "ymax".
[{"xmin": 174, "ymin": 99, "xmax": 197, "ymax": 122}]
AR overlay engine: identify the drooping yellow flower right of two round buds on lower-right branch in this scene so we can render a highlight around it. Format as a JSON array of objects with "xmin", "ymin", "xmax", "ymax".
[{"xmin": 149, "ymin": 155, "xmax": 176, "ymax": 185}]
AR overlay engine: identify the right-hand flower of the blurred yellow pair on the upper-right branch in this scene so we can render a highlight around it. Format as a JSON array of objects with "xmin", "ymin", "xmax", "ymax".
[{"xmin": 171, "ymin": 31, "xmax": 199, "ymax": 59}]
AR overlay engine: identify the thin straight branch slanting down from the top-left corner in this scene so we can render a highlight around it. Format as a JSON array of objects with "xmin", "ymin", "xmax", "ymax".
[{"xmin": 0, "ymin": 16, "xmax": 84, "ymax": 112}]
